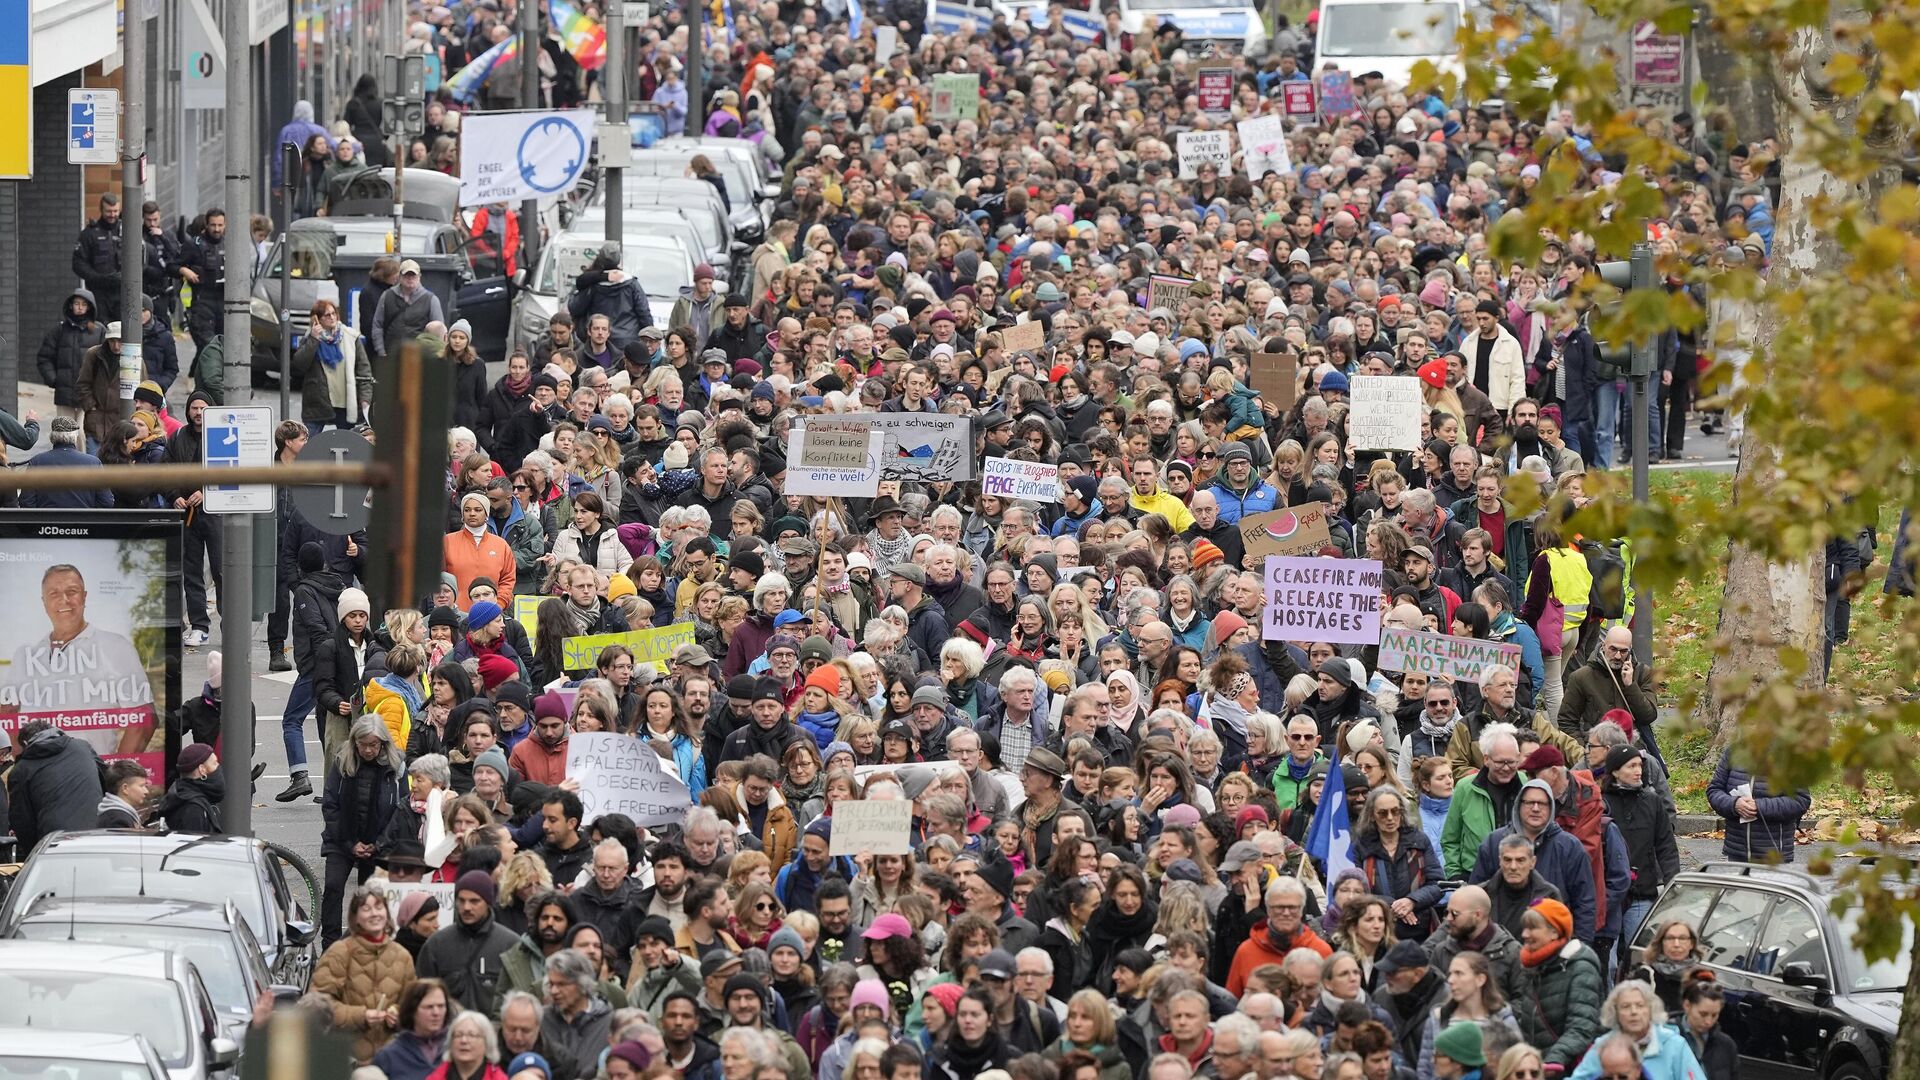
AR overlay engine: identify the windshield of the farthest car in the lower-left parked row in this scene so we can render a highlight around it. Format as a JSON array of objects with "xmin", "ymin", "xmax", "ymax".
[{"xmin": 13, "ymin": 847, "xmax": 278, "ymax": 938}]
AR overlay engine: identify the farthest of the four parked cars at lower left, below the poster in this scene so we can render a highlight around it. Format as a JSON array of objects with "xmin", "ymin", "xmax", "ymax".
[{"xmin": 0, "ymin": 830, "xmax": 321, "ymax": 986}]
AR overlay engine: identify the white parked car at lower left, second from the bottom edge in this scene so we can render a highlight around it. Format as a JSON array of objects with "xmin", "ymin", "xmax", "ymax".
[{"xmin": 0, "ymin": 942, "xmax": 240, "ymax": 1080}]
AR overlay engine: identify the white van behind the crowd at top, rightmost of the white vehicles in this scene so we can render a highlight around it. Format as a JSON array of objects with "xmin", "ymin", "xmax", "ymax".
[{"xmin": 1313, "ymin": 0, "xmax": 1467, "ymax": 90}]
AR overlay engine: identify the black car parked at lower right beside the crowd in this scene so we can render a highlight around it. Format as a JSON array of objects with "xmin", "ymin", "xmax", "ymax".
[{"xmin": 1634, "ymin": 863, "xmax": 1912, "ymax": 1080}]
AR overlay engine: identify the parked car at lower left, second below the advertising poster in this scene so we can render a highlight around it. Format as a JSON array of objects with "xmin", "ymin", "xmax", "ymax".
[{"xmin": 12, "ymin": 897, "xmax": 293, "ymax": 1022}]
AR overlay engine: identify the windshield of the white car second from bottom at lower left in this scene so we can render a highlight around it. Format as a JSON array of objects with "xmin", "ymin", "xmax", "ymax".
[{"xmin": 0, "ymin": 970, "xmax": 188, "ymax": 1076}]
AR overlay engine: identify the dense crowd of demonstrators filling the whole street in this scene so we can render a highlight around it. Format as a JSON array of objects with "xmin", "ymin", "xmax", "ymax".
[{"xmin": 12, "ymin": 0, "xmax": 1845, "ymax": 1080}]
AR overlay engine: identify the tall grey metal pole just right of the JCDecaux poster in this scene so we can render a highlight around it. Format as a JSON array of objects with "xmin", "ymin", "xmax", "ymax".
[{"xmin": 219, "ymin": 4, "xmax": 257, "ymax": 836}]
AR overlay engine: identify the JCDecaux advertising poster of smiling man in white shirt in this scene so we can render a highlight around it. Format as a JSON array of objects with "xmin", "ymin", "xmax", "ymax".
[{"xmin": 0, "ymin": 511, "xmax": 180, "ymax": 778}]
